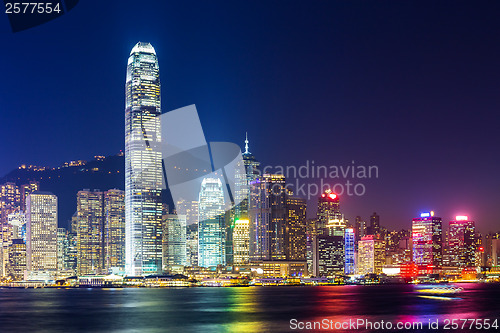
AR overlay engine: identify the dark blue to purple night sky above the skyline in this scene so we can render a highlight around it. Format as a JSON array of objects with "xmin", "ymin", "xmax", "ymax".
[{"xmin": 0, "ymin": 1, "xmax": 500, "ymax": 232}]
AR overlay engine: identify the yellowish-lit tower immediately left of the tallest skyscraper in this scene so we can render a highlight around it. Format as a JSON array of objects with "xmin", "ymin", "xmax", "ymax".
[{"xmin": 103, "ymin": 189, "xmax": 125, "ymax": 272}]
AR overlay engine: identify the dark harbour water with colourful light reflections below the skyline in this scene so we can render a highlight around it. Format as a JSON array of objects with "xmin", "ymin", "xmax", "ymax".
[{"xmin": 0, "ymin": 284, "xmax": 500, "ymax": 332}]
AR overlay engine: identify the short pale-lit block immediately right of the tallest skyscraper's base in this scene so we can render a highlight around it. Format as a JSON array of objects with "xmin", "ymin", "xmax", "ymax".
[{"xmin": 162, "ymin": 214, "xmax": 187, "ymax": 272}]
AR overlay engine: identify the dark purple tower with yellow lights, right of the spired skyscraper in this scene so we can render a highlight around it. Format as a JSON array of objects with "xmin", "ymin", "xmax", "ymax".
[{"xmin": 249, "ymin": 174, "xmax": 287, "ymax": 261}]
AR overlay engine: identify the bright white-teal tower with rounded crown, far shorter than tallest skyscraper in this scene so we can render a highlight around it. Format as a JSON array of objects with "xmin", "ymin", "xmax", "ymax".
[{"xmin": 198, "ymin": 178, "xmax": 226, "ymax": 267}]
